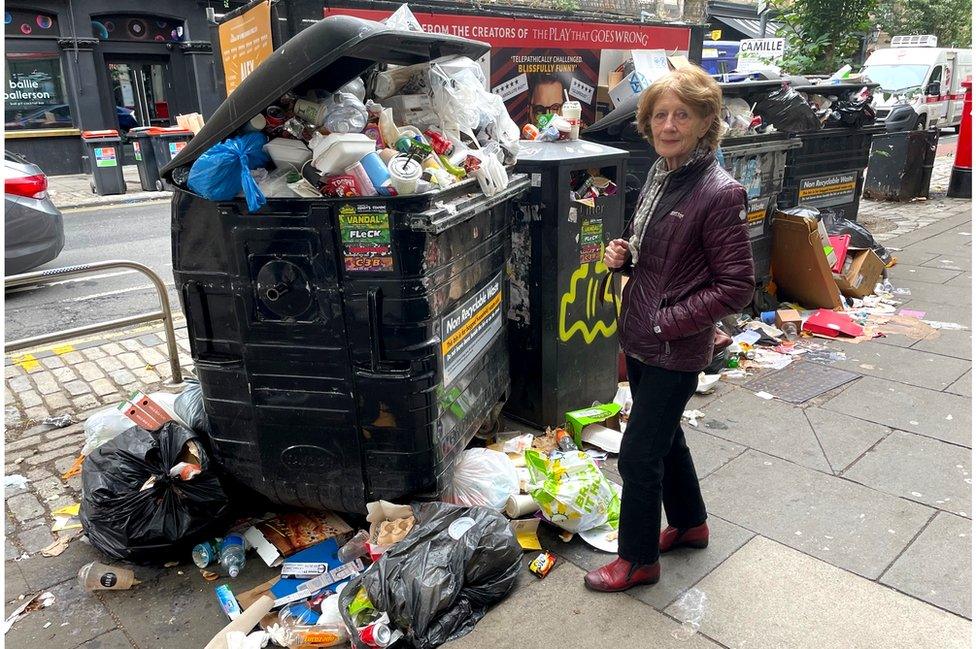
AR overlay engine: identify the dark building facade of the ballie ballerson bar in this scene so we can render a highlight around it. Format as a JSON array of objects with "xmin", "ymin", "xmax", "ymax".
[{"xmin": 4, "ymin": 0, "xmax": 232, "ymax": 175}]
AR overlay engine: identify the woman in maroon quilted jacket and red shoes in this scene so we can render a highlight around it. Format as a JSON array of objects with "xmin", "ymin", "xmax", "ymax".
[{"xmin": 585, "ymin": 67, "xmax": 754, "ymax": 592}]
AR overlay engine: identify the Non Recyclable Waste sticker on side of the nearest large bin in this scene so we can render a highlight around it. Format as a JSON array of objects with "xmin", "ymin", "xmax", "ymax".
[{"xmin": 441, "ymin": 273, "xmax": 502, "ymax": 385}]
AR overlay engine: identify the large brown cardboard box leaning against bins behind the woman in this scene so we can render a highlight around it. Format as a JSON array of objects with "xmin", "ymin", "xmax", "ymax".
[{"xmin": 771, "ymin": 212, "xmax": 843, "ymax": 309}]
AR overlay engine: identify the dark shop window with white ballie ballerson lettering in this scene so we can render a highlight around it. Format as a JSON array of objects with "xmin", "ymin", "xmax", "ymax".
[{"xmin": 3, "ymin": 52, "xmax": 74, "ymax": 131}]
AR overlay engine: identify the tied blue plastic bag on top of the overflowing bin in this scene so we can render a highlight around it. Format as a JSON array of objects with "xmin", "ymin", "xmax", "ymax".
[{"xmin": 187, "ymin": 133, "xmax": 271, "ymax": 212}]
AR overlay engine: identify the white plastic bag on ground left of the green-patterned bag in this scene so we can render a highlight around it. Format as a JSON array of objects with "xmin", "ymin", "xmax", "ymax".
[{"xmin": 448, "ymin": 448, "xmax": 519, "ymax": 511}]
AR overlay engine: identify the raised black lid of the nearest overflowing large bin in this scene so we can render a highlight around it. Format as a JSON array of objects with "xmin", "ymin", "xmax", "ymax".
[{"xmin": 161, "ymin": 16, "xmax": 491, "ymax": 180}]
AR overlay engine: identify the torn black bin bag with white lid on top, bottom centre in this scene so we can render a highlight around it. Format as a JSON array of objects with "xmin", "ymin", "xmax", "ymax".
[{"xmin": 339, "ymin": 502, "xmax": 522, "ymax": 649}]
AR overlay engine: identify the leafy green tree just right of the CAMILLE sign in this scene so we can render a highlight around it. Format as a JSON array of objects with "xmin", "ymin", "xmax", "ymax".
[{"xmin": 771, "ymin": 0, "xmax": 880, "ymax": 74}]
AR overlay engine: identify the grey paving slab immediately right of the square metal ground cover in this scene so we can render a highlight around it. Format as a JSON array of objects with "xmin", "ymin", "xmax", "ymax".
[{"xmin": 832, "ymin": 342, "xmax": 972, "ymax": 390}]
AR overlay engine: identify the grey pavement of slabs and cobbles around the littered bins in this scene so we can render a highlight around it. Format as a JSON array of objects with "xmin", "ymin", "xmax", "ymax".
[{"xmin": 4, "ymin": 161, "xmax": 972, "ymax": 649}]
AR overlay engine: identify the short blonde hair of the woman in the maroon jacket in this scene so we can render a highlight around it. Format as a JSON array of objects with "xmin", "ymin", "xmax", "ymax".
[{"xmin": 637, "ymin": 65, "xmax": 725, "ymax": 151}]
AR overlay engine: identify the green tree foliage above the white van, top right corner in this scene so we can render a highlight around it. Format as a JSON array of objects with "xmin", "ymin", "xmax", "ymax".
[{"xmin": 876, "ymin": 0, "xmax": 973, "ymax": 47}]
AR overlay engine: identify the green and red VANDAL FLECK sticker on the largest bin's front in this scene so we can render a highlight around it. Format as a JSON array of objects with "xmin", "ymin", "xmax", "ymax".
[{"xmin": 339, "ymin": 205, "xmax": 393, "ymax": 272}]
